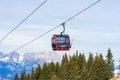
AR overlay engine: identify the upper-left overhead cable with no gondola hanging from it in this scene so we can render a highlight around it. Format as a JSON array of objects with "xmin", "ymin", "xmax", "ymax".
[{"xmin": 0, "ymin": 0, "xmax": 47, "ymax": 42}]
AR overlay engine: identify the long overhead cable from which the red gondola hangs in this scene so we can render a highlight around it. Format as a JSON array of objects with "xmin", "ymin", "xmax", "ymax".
[{"xmin": 14, "ymin": 0, "xmax": 101, "ymax": 51}]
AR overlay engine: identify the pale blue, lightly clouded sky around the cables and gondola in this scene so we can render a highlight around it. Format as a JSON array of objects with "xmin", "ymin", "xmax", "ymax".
[{"xmin": 0, "ymin": 0, "xmax": 120, "ymax": 63}]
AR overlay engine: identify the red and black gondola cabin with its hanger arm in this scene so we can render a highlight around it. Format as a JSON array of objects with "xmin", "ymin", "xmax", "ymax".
[{"xmin": 51, "ymin": 24, "xmax": 71, "ymax": 51}]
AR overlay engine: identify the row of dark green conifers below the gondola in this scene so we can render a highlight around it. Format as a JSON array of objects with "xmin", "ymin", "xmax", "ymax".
[{"xmin": 14, "ymin": 49, "xmax": 114, "ymax": 80}]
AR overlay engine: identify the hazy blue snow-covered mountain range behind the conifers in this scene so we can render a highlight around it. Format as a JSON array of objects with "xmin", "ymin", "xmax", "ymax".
[{"xmin": 0, "ymin": 52, "xmax": 62, "ymax": 80}]
